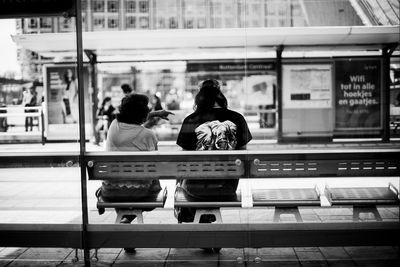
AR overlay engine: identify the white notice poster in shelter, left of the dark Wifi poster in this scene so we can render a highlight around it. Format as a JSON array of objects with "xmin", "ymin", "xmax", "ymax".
[{"xmin": 282, "ymin": 64, "xmax": 332, "ymax": 109}]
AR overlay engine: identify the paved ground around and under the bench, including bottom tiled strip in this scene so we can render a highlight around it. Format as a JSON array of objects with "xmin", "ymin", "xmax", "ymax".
[{"xmin": 0, "ymin": 140, "xmax": 400, "ymax": 267}]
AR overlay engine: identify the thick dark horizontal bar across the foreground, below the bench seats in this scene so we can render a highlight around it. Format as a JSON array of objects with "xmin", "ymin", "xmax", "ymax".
[{"xmin": 0, "ymin": 222, "xmax": 400, "ymax": 248}]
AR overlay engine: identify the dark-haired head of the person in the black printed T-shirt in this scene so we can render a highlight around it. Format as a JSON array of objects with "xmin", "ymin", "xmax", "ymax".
[{"xmin": 194, "ymin": 79, "xmax": 228, "ymax": 113}]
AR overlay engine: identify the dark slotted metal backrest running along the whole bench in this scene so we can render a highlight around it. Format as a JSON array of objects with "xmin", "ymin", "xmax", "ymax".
[{"xmin": 86, "ymin": 151, "xmax": 400, "ymax": 180}]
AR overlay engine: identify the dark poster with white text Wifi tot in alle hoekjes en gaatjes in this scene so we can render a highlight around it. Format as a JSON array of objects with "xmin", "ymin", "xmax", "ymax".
[{"xmin": 335, "ymin": 59, "xmax": 382, "ymax": 130}]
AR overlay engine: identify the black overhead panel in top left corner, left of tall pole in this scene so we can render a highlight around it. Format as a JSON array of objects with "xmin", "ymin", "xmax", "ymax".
[{"xmin": 0, "ymin": 0, "xmax": 77, "ymax": 18}]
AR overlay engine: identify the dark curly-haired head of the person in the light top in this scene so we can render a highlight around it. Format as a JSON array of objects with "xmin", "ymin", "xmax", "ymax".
[{"xmin": 117, "ymin": 94, "xmax": 150, "ymax": 124}]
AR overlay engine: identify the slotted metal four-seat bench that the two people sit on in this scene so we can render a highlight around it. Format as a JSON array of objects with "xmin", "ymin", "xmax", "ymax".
[{"xmin": 88, "ymin": 150, "xmax": 400, "ymax": 226}]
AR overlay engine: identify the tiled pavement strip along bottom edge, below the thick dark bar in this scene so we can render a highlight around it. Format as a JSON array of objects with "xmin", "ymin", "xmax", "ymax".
[{"xmin": 0, "ymin": 247, "xmax": 400, "ymax": 267}]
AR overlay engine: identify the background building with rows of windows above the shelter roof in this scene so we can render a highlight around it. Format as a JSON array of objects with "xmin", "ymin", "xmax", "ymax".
[{"xmin": 17, "ymin": 0, "xmax": 400, "ymax": 80}]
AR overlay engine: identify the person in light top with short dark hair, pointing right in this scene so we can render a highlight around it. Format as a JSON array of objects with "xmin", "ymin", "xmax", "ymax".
[{"xmin": 101, "ymin": 94, "xmax": 172, "ymax": 223}]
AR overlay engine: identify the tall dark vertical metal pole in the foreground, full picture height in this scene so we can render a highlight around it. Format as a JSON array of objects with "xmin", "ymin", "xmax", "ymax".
[{"xmin": 75, "ymin": 0, "xmax": 90, "ymax": 266}]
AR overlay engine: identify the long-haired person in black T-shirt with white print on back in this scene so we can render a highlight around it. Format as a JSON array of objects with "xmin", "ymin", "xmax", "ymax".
[{"xmin": 176, "ymin": 80, "xmax": 252, "ymax": 222}]
